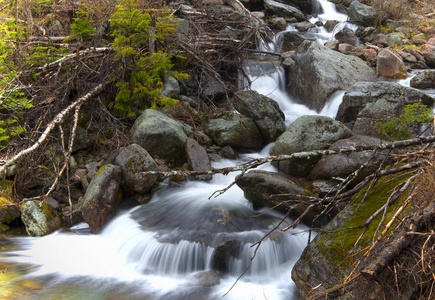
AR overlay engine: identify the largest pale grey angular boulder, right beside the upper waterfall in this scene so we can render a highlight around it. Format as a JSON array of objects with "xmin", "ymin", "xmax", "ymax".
[{"xmin": 288, "ymin": 41, "xmax": 376, "ymax": 111}]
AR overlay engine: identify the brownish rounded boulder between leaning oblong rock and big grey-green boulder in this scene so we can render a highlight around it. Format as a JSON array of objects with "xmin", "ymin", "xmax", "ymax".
[{"xmin": 115, "ymin": 144, "xmax": 158, "ymax": 194}]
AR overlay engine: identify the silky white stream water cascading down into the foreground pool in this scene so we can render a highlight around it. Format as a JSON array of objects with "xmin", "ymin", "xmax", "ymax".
[{"xmin": 0, "ymin": 0, "xmax": 384, "ymax": 300}]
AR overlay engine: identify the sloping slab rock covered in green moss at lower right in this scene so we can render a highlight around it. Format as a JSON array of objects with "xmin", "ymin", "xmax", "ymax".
[{"xmin": 292, "ymin": 169, "xmax": 411, "ymax": 295}]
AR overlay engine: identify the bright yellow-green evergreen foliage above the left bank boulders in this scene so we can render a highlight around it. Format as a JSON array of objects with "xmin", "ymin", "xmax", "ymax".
[{"xmin": 110, "ymin": 0, "xmax": 187, "ymax": 117}]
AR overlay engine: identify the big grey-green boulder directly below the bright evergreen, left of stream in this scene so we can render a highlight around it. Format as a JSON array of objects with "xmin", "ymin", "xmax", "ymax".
[{"xmin": 131, "ymin": 109, "xmax": 187, "ymax": 163}]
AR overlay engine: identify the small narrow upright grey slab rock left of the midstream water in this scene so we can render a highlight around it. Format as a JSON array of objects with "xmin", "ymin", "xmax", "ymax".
[{"xmin": 186, "ymin": 138, "xmax": 211, "ymax": 180}]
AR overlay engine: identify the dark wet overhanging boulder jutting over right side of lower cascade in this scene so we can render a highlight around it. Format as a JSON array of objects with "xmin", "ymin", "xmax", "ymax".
[{"xmin": 236, "ymin": 171, "xmax": 320, "ymax": 224}]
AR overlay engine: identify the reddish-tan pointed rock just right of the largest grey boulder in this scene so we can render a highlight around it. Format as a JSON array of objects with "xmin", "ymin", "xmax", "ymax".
[{"xmin": 376, "ymin": 49, "xmax": 408, "ymax": 79}]
